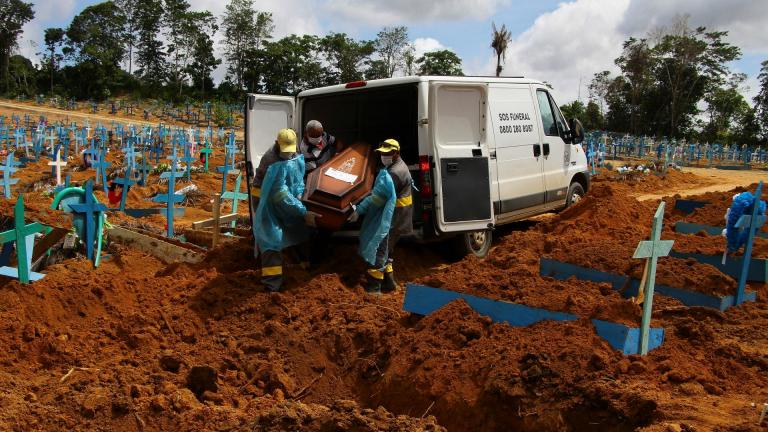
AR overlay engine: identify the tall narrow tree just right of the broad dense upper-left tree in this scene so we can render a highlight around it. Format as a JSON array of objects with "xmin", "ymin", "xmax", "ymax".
[{"xmin": 135, "ymin": 0, "xmax": 168, "ymax": 93}]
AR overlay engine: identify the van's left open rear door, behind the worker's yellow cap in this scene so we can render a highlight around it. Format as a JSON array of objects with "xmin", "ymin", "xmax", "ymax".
[{"xmin": 244, "ymin": 94, "xmax": 296, "ymax": 223}]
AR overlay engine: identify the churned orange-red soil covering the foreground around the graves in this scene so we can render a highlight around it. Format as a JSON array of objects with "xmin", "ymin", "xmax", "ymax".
[{"xmin": 0, "ymin": 112, "xmax": 768, "ymax": 432}]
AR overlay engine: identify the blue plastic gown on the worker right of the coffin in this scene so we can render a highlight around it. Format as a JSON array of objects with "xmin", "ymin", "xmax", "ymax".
[{"xmin": 357, "ymin": 168, "xmax": 397, "ymax": 265}]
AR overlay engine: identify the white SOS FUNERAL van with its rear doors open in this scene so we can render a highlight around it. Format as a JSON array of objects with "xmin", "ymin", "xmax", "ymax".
[{"xmin": 245, "ymin": 76, "xmax": 590, "ymax": 256}]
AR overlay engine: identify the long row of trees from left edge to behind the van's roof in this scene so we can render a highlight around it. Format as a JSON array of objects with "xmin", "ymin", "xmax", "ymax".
[{"xmin": 0, "ymin": 0, "xmax": 463, "ymax": 101}]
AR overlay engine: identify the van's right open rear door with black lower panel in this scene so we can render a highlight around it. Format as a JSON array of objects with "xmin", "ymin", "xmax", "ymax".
[{"xmin": 429, "ymin": 82, "xmax": 493, "ymax": 232}]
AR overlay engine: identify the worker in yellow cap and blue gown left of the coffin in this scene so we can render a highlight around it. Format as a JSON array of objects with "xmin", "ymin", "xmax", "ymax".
[{"xmin": 253, "ymin": 129, "xmax": 317, "ymax": 292}]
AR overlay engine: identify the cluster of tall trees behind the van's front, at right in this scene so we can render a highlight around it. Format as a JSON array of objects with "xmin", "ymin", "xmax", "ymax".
[{"xmin": 561, "ymin": 18, "xmax": 768, "ymax": 145}]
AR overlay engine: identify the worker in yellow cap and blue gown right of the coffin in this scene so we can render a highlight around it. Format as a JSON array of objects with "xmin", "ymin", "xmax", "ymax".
[{"xmin": 349, "ymin": 139, "xmax": 413, "ymax": 295}]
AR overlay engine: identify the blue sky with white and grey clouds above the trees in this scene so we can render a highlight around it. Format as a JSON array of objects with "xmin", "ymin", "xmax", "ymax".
[{"xmin": 19, "ymin": 0, "xmax": 768, "ymax": 104}]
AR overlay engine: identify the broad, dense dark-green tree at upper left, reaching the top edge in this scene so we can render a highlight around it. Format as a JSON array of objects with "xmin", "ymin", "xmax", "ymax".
[{"xmin": 67, "ymin": 1, "xmax": 125, "ymax": 98}]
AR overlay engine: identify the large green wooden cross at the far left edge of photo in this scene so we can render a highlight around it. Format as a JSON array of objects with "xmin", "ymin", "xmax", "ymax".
[{"xmin": 0, "ymin": 195, "xmax": 47, "ymax": 284}]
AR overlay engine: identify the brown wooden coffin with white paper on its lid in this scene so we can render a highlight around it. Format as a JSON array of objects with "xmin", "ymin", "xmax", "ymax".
[{"xmin": 303, "ymin": 142, "xmax": 376, "ymax": 231}]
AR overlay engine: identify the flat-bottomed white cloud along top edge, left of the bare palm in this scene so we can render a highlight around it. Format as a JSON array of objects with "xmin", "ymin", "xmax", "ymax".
[{"xmin": 325, "ymin": 0, "xmax": 509, "ymax": 26}]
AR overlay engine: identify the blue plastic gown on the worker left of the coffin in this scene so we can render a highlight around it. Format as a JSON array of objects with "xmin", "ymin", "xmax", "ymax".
[{"xmin": 254, "ymin": 156, "xmax": 309, "ymax": 251}]
